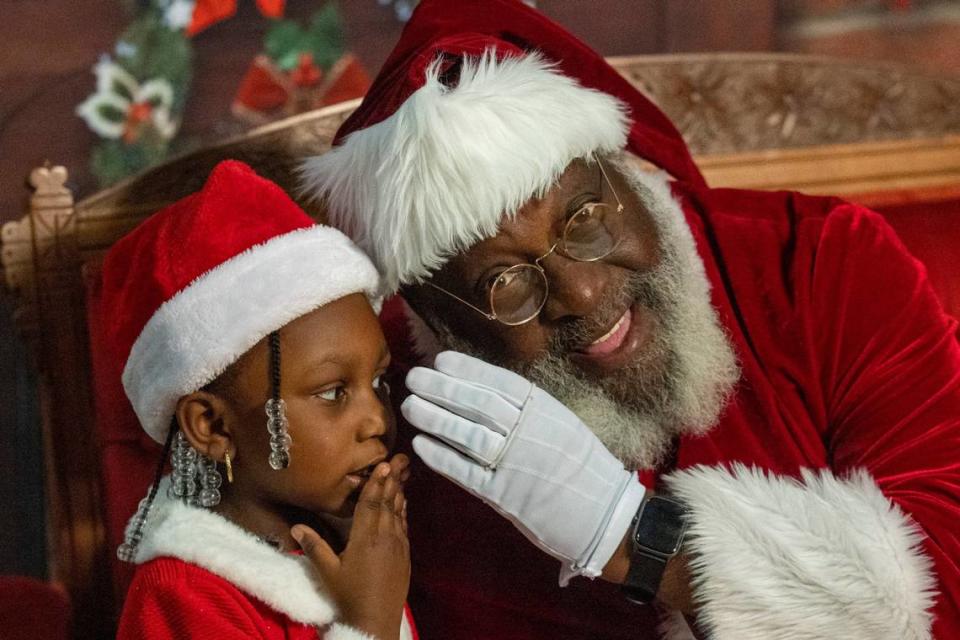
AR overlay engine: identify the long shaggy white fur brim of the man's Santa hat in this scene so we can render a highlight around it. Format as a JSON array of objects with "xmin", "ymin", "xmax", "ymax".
[{"xmin": 301, "ymin": 51, "xmax": 629, "ymax": 293}]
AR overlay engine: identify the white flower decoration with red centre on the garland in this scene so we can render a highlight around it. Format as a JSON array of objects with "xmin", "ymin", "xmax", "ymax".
[{"xmin": 77, "ymin": 56, "xmax": 178, "ymax": 143}]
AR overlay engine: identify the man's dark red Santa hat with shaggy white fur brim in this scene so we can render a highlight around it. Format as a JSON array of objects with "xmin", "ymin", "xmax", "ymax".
[{"xmin": 302, "ymin": 0, "xmax": 703, "ymax": 292}]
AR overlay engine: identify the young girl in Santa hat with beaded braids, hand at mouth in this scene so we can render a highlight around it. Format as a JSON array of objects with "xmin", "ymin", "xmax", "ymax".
[{"xmin": 103, "ymin": 162, "xmax": 414, "ymax": 640}]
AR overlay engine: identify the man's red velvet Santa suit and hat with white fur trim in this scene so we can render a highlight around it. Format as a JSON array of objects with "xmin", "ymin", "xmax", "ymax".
[{"xmin": 304, "ymin": 0, "xmax": 960, "ymax": 640}]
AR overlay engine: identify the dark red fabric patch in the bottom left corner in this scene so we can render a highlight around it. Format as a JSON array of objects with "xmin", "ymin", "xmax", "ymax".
[{"xmin": 0, "ymin": 576, "xmax": 72, "ymax": 640}]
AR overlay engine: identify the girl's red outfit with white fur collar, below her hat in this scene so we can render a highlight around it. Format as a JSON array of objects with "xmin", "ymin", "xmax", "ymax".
[{"xmin": 117, "ymin": 478, "xmax": 416, "ymax": 640}]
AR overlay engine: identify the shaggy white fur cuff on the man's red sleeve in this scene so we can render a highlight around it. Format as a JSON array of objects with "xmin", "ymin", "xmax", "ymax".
[{"xmin": 667, "ymin": 465, "xmax": 935, "ymax": 640}]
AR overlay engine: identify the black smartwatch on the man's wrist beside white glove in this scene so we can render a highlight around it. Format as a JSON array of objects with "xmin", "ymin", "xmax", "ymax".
[{"xmin": 621, "ymin": 495, "xmax": 687, "ymax": 604}]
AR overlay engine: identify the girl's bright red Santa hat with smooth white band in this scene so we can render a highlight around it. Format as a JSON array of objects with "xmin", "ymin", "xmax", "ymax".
[{"xmin": 102, "ymin": 161, "xmax": 379, "ymax": 442}]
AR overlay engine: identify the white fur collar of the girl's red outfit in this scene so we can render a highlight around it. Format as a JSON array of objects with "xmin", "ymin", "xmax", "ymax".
[{"xmin": 134, "ymin": 476, "xmax": 336, "ymax": 626}]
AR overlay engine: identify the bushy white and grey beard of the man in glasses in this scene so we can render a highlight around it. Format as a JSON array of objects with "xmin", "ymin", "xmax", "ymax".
[{"xmin": 410, "ymin": 158, "xmax": 740, "ymax": 469}]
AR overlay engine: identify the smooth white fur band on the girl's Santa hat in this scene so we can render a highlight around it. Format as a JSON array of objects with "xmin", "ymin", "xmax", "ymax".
[{"xmin": 123, "ymin": 225, "xmax": 380, "ymax": 442}]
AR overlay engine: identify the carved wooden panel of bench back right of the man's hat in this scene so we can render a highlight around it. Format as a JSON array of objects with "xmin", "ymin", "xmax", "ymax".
[{"xmin": 611, "ymin": 53, "xmax": 960, "ymax": 155}]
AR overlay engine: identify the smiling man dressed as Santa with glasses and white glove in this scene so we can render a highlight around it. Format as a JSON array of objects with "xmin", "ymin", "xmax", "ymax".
[{"xmin": 303, "ymin": 0, "xmax": 960, "ymax": 640}]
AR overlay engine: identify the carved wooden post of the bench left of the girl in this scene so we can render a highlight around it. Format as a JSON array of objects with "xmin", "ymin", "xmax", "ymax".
[{"xmin": 3, "ymin": 166, "xmax": 113, "ymax": 638}]
